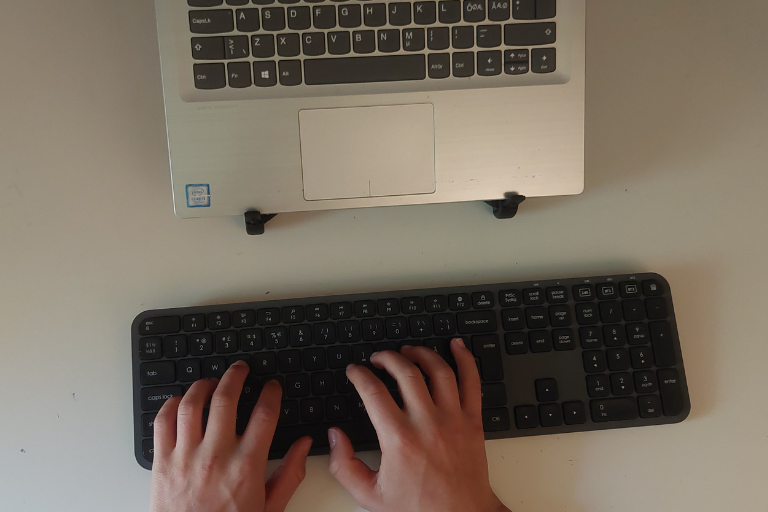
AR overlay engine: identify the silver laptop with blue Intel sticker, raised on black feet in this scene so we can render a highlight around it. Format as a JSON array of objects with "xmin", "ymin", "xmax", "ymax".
[{"xmin": 156, "ymin": 0, "xmax": 586, "ymax": 224}]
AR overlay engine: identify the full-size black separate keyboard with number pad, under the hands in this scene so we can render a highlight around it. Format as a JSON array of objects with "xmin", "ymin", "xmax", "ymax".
[{"xmin": 131, "ymin": 274, "xmax": 690, "ymax": 469}]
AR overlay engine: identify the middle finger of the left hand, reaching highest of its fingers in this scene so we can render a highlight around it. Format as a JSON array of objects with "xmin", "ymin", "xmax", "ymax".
[{"xmin": 205, "ymin": 361, "xmax": 248, "ymax": 442}]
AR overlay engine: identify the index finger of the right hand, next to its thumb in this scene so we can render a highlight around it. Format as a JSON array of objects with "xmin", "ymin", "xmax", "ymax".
[{"xmin": 347, "ymin": 364, "xmax": 405, "ymax": 439}]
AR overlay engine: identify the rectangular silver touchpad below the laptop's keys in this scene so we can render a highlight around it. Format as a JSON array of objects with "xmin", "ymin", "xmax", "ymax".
[{"xmin": 299, "ymin": 104, "xmax": 435, "ymax": 201}]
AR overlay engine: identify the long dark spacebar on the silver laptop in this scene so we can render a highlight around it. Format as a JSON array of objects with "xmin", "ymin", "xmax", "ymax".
[{"xmin": 304, "ymin": 55, "xmax": 427, "ymax": 85}]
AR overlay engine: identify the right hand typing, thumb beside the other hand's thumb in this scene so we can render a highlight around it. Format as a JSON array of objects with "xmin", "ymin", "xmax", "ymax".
[{"xmin": 328, "ymin": 338, "xmax": 509, "ymax": 512}]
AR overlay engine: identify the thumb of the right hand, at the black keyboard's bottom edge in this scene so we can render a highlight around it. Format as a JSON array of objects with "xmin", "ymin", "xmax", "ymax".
[{"xmin": 328, "ymin": 427, "xmax": 376, "ymax": 509}]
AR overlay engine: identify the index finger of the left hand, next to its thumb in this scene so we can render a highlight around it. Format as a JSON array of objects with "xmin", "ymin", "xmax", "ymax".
[{"xmin": 241, "ymin": 380, "xmax": 282, "ymax": 464}]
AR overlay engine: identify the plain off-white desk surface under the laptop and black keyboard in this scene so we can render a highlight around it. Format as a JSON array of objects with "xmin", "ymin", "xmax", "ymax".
[{"xmin": 0, "ymin": 0, "xmax": 768, "ymax": 512}]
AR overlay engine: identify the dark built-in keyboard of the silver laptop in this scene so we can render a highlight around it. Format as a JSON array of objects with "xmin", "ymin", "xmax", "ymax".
[{"xmin": 188, "ymin": 0, "xmax": 557, "ymax": 90}]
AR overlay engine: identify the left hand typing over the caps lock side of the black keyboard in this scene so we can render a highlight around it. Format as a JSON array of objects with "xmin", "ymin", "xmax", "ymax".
[{"xmin": 150, "ymin": 361, "xmax": 312, "ymax": 512}]
